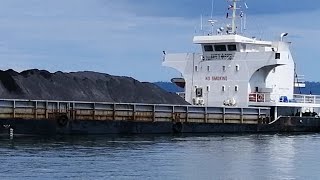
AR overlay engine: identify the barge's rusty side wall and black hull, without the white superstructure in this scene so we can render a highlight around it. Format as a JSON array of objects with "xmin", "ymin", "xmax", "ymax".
[{"xmin": 0, "ymin": 99, "xmax": 320, "ymax": 135}]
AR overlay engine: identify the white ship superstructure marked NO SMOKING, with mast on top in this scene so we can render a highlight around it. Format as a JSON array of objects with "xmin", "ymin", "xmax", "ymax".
[{"xmin": 163, "ymin": 0, "xmax": 320, "ymax": 117}]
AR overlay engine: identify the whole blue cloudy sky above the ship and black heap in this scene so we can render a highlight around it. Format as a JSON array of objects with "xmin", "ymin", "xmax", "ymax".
[{"xmin": 0, "ymin": 0, "xmax": 320, "ymax": 82}]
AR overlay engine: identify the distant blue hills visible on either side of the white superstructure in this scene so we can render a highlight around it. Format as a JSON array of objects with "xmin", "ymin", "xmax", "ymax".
[{"xmin": 154, "ymin": 82, "xmax": 320, "ymax": 95}]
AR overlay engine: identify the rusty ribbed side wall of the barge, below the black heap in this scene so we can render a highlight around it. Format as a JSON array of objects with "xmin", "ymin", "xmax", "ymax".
[{"xmin": 0, "ymin": 99, "xmax": 270, "ymax": 124}]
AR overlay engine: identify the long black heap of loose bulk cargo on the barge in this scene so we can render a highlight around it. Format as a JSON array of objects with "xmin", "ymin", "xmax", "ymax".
[{"xmin": 0, "ymin": 69, "xmax": 187, "ymax": 104}]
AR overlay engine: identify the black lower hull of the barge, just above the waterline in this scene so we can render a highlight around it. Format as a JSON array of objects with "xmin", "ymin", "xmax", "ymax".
[{"xmin": 0, "ymin": 117, "xmax": 320, "ymax": 135}]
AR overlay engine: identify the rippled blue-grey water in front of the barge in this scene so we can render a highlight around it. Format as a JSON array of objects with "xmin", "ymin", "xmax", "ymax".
[{"xmin": 0, "ymin": 134, "xmax": 320, "ymax": 180}]
